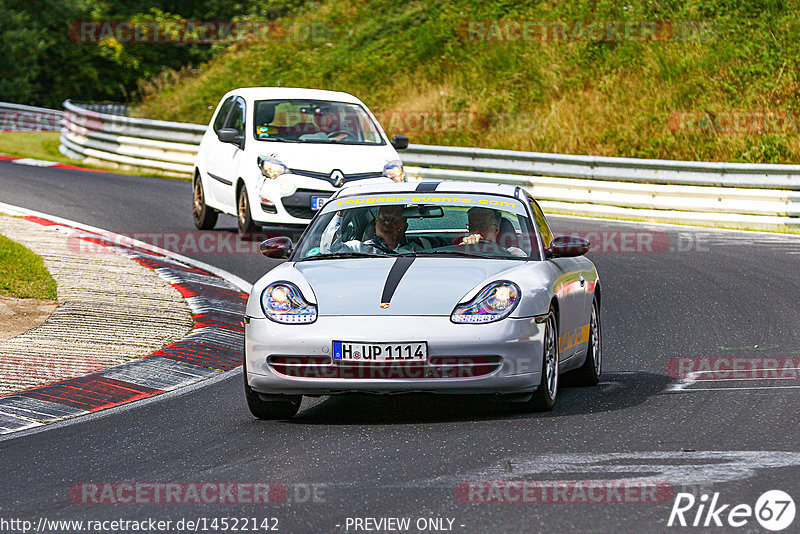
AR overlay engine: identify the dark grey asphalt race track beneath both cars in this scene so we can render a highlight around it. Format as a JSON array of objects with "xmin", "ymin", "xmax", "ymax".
[{"xmin": 0, "ymin": 163, "xmax": 800, "ymax": 533}]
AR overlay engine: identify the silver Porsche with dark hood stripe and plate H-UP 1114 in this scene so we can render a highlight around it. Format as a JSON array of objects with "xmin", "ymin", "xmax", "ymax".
[{"xmin": 244, "ymin": 182, "xmax": 602, "ymax": 419}]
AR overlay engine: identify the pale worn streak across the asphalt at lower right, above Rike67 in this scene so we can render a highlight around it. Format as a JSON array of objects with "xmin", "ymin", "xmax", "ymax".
[{"xmin": 416, "ymin": 451, "xmax": 800, "ymax": 487}]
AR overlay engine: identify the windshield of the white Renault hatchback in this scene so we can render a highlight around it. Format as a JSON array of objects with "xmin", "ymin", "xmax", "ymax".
[{"xmin": 253, "ymin": 100, "xmax": 384, "ymax": 145}]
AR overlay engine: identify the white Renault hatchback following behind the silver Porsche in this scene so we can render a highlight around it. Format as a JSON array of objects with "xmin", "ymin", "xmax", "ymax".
[{"xmin": 192, "ymin": 87, "xmax": 408, "ymax": 233}]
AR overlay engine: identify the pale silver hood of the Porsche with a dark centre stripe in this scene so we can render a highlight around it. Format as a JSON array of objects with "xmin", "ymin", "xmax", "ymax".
[{"xmin": 294, "ymin": 257, "xmax": 522, "ymax": 316}]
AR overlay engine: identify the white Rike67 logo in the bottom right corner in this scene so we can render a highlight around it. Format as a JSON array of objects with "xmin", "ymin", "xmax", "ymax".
[{"xmin": 667, "ymin": 490, "xmax": 796, "ymax": 532}]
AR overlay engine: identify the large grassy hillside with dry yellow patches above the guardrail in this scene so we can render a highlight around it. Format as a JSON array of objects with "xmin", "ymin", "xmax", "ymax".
[{"xmin": 135, "ymin": 0, "xmax": 800, "ymax": 163}]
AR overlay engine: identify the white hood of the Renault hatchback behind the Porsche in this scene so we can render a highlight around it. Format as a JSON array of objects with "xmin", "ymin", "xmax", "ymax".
[{"xmin": 248, "ymin": 140, "xmax": 400, "ymax": 174}]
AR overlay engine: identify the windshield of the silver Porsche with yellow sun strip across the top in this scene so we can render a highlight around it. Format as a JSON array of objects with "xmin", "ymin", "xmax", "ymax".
[{"xmin": 292, "ymin": 193, "xmax": 540, "ymax": 261}]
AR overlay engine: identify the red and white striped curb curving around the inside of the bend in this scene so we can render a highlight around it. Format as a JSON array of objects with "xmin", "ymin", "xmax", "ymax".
[{"xmin": 0, "ymin": 203, "xmax": 250, "ymax": 434}]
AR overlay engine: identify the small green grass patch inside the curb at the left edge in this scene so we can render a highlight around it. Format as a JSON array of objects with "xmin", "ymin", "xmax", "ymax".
[{"xmin": 0, "ymin": 235, "xmax": 56, "ymax": 300}]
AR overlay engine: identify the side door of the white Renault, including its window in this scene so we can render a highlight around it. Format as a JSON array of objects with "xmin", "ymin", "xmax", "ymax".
[{"xmin": 206, "ymin": 96, "xmax": 246, "ymax": 211}]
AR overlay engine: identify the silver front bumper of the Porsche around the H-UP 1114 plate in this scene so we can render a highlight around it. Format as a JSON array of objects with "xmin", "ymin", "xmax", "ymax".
[{"xmin": 245, "ymin": 316, "xmax": 544, "ymax": 395}]
